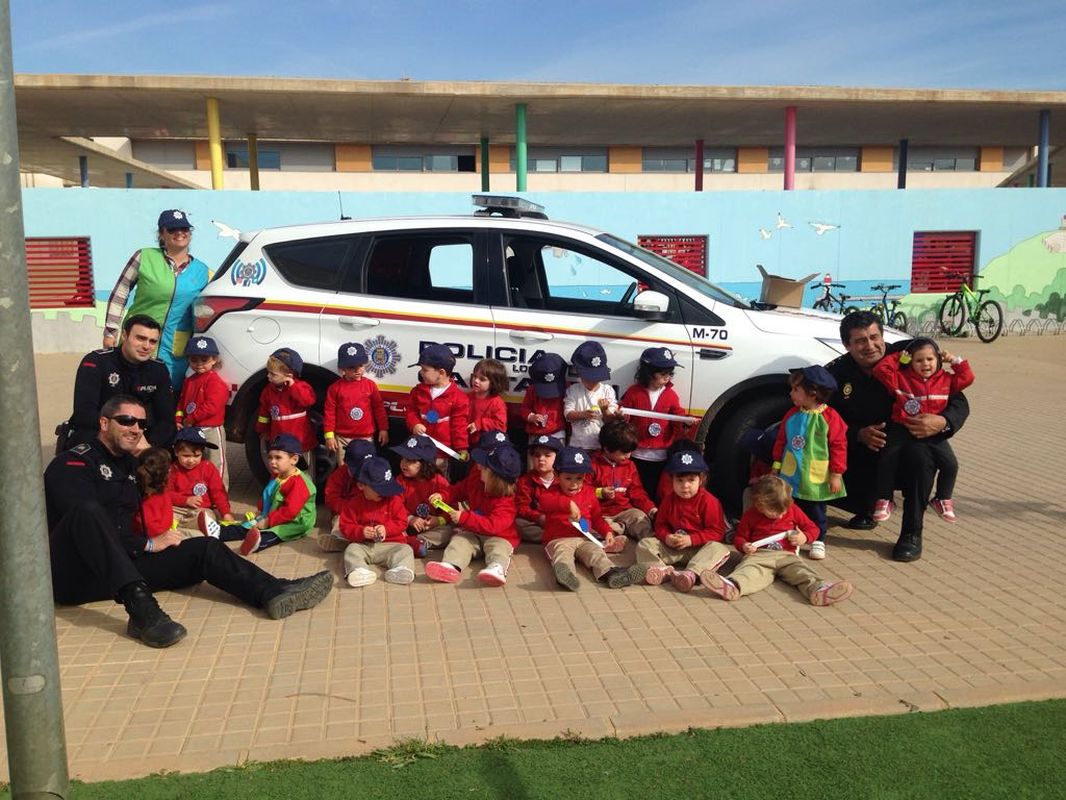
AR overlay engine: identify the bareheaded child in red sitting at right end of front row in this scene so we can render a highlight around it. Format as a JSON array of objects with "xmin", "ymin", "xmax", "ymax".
[{"xmin": 700, "ymin": 475, "xmax": 852, "ymax": 606}]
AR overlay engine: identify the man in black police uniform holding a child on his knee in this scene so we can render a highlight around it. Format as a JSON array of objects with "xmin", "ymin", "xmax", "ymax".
[{"xmin": 827, "ymin": 311, "xmax": 970, "ymax": 561}]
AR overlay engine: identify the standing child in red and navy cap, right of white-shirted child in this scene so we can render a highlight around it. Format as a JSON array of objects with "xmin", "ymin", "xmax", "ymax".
[{"xmin": 621, "ymin": 348, "xmax": 699, "ymax": 499}]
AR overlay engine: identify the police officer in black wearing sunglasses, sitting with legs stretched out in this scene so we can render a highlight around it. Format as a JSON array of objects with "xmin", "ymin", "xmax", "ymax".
[{"xmin": 45, "ymin": 395, "xmax": 333, "ymax": 647}]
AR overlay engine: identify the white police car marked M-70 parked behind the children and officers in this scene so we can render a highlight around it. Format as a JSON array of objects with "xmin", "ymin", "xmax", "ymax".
[{"xmin": 195, "ymin": 195, "xmax": 843, "ymax": 502}]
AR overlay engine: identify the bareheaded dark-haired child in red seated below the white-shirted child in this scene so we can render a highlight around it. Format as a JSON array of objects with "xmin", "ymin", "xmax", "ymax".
[{"xmin": 593, "ymin": 419, "xmax": 659, "ymax": 553}]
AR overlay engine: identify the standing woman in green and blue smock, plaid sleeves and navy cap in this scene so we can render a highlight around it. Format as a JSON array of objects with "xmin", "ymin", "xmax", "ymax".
[{"xmin": 103, "ymin": 209, "xmax": 211, "ymax": 393}]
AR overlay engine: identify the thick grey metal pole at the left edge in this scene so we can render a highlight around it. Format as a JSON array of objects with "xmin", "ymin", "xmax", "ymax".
[{"xmin": 0, "ymin": 0, "xmax": 70, "ymax": 800}]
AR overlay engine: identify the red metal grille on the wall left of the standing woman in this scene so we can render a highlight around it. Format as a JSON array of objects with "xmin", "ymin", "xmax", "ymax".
[{"xmin": 26, "ymin": 237, "xmax": 96, "ymax": 308}]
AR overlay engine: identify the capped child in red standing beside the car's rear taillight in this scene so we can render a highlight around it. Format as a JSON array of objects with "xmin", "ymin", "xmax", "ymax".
[{"xmin": 174, "ymin": 336, "xmax": 229, "ymax": 490}]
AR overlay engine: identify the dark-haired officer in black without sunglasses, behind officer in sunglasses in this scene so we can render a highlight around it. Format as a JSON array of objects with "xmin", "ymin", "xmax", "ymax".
[{"xmin": 59, "ymin": 314, "xmax": 175, "ymax": 450}]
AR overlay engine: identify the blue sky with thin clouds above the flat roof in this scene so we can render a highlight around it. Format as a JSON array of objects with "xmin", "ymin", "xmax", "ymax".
[{"xmin": 10, "ymin": 0, "xmax": 1066, "ymax": 90}]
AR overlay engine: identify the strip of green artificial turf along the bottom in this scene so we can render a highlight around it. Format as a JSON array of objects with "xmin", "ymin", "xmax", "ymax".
[{"xmin": 3, "ymin": 701, "xmax": 1066, "ymax": 800}]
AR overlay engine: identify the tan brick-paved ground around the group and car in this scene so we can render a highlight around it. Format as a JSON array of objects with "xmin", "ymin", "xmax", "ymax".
[{"xmin": 3, "ymin": 337, "xmax": 1066, "ymax": 780}]
